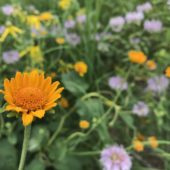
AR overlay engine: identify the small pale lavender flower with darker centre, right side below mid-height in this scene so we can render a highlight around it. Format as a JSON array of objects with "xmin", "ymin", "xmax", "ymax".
[{"xmin": 132, "ymin": 101, "xmax": 149, "ymax": 116}]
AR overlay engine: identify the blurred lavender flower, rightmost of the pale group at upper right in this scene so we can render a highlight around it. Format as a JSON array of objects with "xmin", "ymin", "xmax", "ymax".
[{"xmin": 144, "ymin": 20, "xmax": 162, "ymax": 33}]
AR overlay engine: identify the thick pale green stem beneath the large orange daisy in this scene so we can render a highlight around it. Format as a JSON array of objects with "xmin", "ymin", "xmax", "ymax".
[{"xmin": 18, "ymin": 125, "xmax": 31, "ymax": 170}]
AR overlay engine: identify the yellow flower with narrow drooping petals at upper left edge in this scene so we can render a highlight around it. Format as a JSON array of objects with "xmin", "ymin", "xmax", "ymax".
[{"xmin": 0, "ymin": 25, "xmax": 23, "ymax": 42}]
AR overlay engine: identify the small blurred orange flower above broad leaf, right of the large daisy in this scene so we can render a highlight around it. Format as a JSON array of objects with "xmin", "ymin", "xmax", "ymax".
[{"xmin": 74, "ymin": 61, "xmax": 87, "ymax": 77}]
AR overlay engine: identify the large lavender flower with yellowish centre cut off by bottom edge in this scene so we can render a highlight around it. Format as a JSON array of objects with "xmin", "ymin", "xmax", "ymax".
[{"xmin": 100, "ymin": 146, "xmax": 132, "ymax": 170}]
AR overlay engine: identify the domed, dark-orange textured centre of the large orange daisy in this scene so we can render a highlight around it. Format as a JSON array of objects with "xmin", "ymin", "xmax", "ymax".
[{"xmin": 14, "ymin": 87, "xmax": 46, "ymax": 111}]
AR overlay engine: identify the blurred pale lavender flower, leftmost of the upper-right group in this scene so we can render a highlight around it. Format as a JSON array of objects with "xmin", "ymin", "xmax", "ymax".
[{"xmin": 109, "ymin": 16, "xmax": 125, "ymax": 32}]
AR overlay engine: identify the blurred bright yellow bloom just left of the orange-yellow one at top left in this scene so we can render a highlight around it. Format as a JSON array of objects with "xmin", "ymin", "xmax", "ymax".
[{"xmin": 27, "ymin": 15, "xmax": 41, "ymax": 29}]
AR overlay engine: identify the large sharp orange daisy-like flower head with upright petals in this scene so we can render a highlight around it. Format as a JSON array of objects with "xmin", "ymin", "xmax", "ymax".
[{"xmin": 4, "ymin": 71, "xmax": 64, "ymax": 126}]
